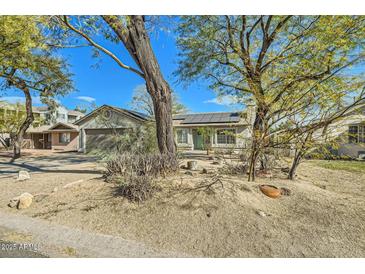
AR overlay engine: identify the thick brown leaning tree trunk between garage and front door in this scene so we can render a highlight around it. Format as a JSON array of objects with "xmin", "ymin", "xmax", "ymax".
[{"xmin": 103, "ymin": 15, "xmax": 176, "ymax": 154}]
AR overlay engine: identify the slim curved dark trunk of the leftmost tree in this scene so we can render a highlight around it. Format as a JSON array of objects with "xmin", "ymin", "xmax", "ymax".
[{"xmin": 13, "ymin": 83, "xmax": 34, "ymax": 159}]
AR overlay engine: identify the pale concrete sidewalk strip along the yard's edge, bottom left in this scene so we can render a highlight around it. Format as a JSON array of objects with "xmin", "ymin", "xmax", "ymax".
[{"xmin": 0, "ymin": 211, "xmax": 188, "ymax": 258}]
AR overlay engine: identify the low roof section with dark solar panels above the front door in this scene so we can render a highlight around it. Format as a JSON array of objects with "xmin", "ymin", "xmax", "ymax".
[{"xmin": 173, "ymin": 112, "xmax": 245, "ymax": 124}]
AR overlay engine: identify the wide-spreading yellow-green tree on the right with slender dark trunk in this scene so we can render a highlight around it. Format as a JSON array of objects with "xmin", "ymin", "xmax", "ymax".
[{"xmin": 177, "ymin": 15, "xmax": 365, "ymax": 181}]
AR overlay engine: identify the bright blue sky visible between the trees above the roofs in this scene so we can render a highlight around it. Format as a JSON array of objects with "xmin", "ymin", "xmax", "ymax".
[{"xmin": 1, "ymin": 23, "xmax": 237, "ymax": 112}]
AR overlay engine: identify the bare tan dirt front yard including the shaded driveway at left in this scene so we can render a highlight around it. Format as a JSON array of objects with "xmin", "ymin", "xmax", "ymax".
[{"xmin": 0, "ymin": 151, "xmax": 365, "ymax": 257}]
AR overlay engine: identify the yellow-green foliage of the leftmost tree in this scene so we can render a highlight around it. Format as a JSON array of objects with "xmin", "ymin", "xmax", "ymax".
[{"xmin": 0, "ymin": 16, "xmax": 73, "ymax": 106}]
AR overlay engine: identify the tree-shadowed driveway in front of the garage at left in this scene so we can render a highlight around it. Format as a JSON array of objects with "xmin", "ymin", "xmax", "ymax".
[{"xmin": 0, "ymin": 150, "xmax": 100, "ymax": 178}]
